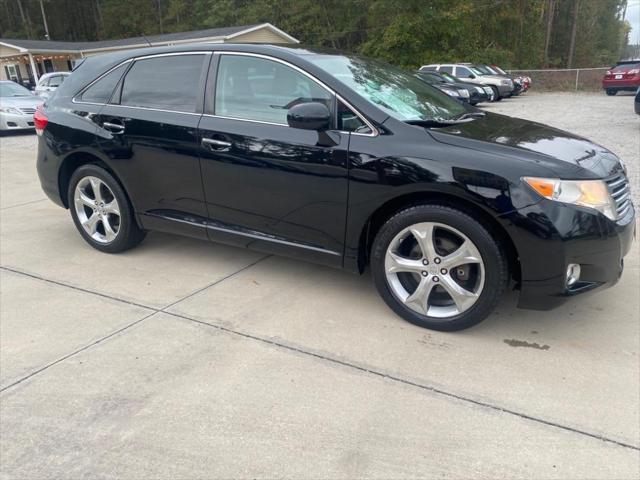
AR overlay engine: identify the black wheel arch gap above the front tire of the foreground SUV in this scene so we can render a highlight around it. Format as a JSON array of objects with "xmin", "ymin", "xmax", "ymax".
[{"xmin": 358, "ymin": 192, "xmax": 521, "ymax": 282}]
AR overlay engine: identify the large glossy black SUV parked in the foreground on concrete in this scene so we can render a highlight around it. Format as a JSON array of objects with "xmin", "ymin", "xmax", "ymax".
[{"xmin": 35, "ymin": 44, "xmax": 635, "ymax": 330}]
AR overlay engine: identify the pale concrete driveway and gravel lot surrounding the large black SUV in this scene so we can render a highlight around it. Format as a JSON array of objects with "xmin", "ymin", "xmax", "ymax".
[{"xmin": 0, "ymin": 94, "xmax": 640, "ymax": 479}]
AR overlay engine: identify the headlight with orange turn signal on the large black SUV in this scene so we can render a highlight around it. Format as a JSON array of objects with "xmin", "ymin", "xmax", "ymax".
[{"xmin": 523, "ymin": 177, "xmax": 617, "ymax": 220}]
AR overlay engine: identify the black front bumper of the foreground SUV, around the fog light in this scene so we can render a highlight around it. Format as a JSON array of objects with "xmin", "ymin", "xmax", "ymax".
[{"xmin": 507, "ymin": 200, "xmax": 636, "ymax": 310}]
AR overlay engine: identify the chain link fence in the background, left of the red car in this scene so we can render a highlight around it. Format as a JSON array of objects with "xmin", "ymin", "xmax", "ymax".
[{"xmin": 509, "ymin": 67, "xmax": 610, "ymax": 92}]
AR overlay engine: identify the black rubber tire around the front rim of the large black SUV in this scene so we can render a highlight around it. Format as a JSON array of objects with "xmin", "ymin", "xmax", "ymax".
[{"xmin": 370, "ymin": 205, "xmax": 509, "ymax": 331}]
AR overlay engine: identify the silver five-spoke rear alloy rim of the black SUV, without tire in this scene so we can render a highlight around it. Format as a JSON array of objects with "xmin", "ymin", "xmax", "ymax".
[{"xmin": 73, "ymin": 176, "xmax": 121, "ymax": 244}]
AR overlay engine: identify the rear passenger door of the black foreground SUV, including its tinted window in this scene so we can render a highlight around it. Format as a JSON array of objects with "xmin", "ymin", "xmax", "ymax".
[{"xmin": 94, "ymin": 52, "xmax": 211, "ymax": 238}]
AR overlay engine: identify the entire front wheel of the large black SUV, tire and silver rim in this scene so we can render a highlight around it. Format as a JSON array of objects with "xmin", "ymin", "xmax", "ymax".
[{"xmin": 371, "ymin": 205, "xmax": 508, "ymax": 331}]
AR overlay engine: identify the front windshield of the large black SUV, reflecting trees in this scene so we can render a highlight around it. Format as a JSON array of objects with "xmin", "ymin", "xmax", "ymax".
[{"xmin": 308, "ymin": 55, "xmax": 467, "ymax": 122}]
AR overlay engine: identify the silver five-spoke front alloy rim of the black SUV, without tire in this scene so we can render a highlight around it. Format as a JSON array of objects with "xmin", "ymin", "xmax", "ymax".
[{"xmin": 385, "ymin": 222, "xmax": 485, "ymax": 319}]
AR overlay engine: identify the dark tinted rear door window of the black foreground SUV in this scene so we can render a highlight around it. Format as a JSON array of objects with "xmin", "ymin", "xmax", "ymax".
[{"xmin": 120, "ymin": 55, "xmax": 205, "ymax": 112}]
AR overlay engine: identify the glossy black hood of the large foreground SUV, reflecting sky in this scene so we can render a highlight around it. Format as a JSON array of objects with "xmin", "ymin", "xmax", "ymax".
[{"xmin": 429, "ymin": 113, "xmax": 622, "ymax": 179}]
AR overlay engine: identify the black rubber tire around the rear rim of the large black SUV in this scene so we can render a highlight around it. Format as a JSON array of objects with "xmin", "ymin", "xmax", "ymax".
[{"xmin": 67, "ymin": 164, "xmax": 146, "ymax": 253}]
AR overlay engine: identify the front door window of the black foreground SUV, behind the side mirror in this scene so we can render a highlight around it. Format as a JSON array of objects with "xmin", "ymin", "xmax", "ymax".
[{"xmin": 214, "ymin": 55, "xmax": 332, "ymax": 125}]
